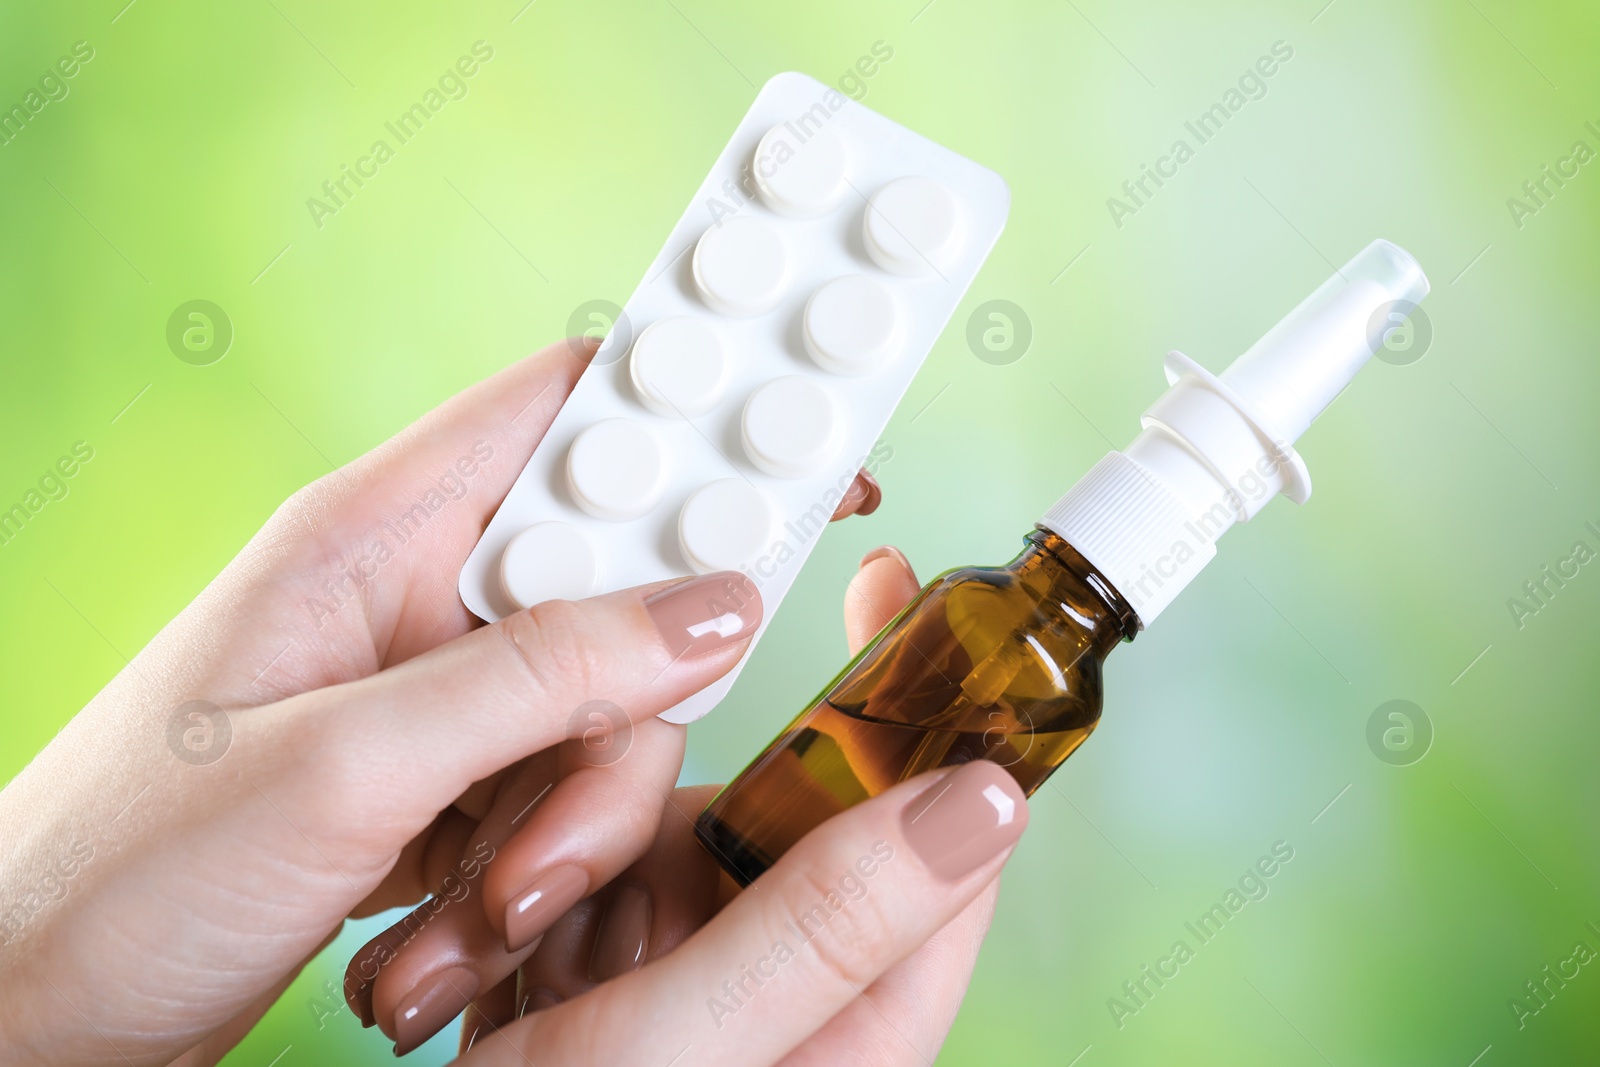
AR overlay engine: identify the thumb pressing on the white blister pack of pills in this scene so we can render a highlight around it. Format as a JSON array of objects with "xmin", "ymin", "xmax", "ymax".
[{"xmin": 276, "ymin": 571, "xmax": 762, "ymax": 817}]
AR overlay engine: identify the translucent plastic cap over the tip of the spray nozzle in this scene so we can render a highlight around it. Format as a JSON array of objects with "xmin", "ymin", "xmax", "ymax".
[{"xmin": 1221, "ymin": 238, "xmax": 1429, "ymax": 445}]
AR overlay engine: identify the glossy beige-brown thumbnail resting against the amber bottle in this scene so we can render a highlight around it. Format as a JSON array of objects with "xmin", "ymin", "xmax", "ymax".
[{"xmin": 901, "ymin": 760, "xmax": 1027, "ymax": 881}]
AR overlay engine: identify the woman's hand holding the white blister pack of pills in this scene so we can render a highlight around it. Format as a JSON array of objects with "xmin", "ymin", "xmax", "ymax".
[{"xmin": 0, "ymin": 335, "xmax": 872, "ymax": 1064}]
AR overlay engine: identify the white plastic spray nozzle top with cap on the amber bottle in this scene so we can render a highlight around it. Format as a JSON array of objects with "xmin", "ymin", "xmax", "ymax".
[{"xmin": 1040, "ymin": 240, "xmax": 1429, "ymax": 625}]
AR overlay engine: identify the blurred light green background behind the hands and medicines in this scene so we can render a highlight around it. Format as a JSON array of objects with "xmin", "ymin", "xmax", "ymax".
[{"xmin": 0, "ymin": 0, "xmax": 1600, "ymax": 1067}]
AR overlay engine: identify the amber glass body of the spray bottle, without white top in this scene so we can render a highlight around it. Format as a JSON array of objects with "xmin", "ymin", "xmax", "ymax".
[{"xmin": 696, "ymin": 528, "xmax": 1139, "ymax": 885}]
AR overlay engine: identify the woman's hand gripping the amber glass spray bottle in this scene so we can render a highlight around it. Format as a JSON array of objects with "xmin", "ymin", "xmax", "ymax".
[{"xmin": 432, "ymin": 549, "xmax": 1027, "ymax": 1067}]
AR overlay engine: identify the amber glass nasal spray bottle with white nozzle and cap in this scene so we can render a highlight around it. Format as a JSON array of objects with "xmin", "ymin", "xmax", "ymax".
[{"xmin": 696, "ymin": 240, "xmax": 1429, "ymax": 885}]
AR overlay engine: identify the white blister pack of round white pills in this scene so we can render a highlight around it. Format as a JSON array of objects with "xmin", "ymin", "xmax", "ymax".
[{"xmin": 461, "ymin": 74, "xmax": 1011, "ymax": 723}]
